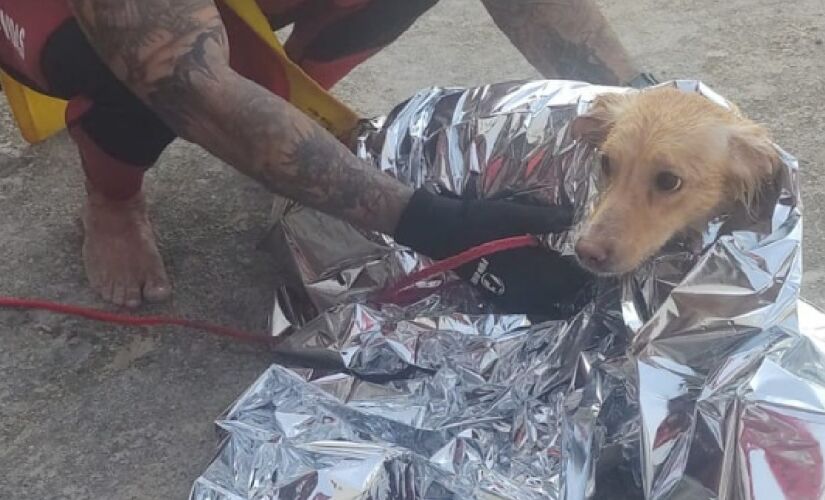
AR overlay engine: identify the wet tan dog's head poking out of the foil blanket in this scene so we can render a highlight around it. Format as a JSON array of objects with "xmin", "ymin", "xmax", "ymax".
[{"xmin": 572, "ymin": 88, "xmax": 779, "ymax": 275}]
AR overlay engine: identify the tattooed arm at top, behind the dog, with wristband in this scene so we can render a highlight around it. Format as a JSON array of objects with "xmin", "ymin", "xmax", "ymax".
[{"xmin": 482, "ymin": 0, "xmax": 639, "ymax": 85}]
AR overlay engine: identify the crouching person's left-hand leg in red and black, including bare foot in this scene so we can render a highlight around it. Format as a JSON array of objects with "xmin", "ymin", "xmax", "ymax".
[{"xmin": 0, "ymin": 0, "xmax": 174, "ymax": 306}]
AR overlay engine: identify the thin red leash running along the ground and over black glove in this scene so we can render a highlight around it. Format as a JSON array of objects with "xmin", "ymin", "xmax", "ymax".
[{"xmin": 0, "ymin": 235, "xmax": 539, "ymax": 345}]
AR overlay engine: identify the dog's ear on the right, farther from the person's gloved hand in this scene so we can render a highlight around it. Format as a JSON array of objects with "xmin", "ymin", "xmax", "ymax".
[{"xmin": 728, "ymin": 123, "xmax": 780, "ymax": 206}]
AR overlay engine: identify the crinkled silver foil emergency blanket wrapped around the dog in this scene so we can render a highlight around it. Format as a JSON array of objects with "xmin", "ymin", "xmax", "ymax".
[{"xmin": 191, "ymin": 81, "xmax": 825, "ymax": 500}]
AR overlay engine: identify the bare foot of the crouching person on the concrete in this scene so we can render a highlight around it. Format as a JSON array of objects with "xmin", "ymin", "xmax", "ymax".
[{"xmin": 82, "ymin": 188, "xmax": 172, "ymax": 308}]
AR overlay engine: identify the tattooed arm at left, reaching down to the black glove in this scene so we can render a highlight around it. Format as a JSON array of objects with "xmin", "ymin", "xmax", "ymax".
[{"xmin": 69, "ymin": 0, "xmax": 412, "ymax": 234}]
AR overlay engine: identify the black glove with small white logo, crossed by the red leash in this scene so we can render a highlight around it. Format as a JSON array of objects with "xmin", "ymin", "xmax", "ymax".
[{"xmin": 394, "ymin": 189, "xmax": 591, "ymax": 317}]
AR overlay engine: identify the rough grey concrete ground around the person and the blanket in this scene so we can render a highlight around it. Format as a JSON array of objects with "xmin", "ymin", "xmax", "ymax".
[{"xmin": 0, "ymin": 0, "xmax": 825, "ymax": 499}]
